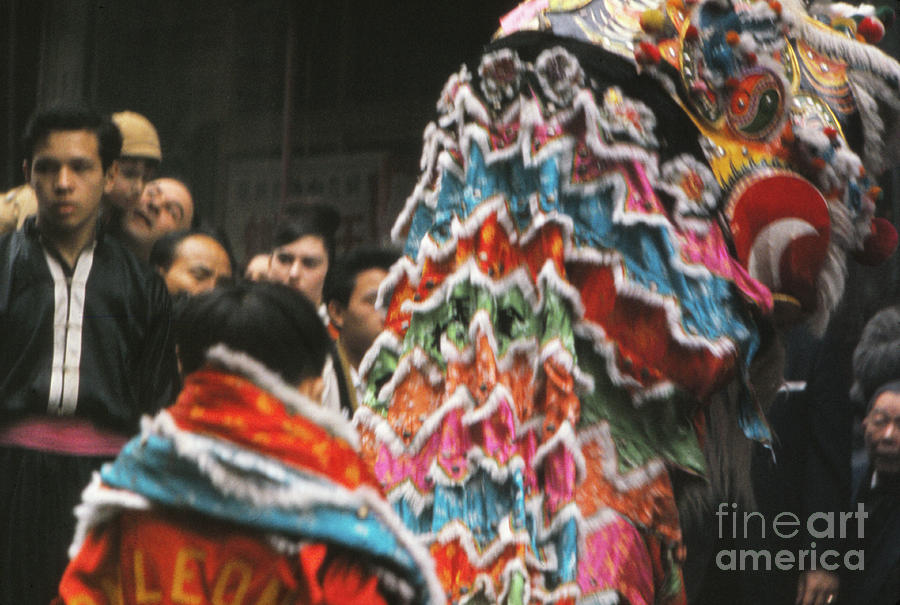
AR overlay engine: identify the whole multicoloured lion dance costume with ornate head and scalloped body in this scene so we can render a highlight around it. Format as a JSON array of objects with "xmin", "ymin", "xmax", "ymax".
[{"xmin": 354, "ymin": 0, "xmax": 900, "ymax": 605}]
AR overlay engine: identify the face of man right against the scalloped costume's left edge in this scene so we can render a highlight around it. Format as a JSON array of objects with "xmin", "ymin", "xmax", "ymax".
[{"xmin": 330, "ymin": 267, "xmax": 388, "ymax": 359}]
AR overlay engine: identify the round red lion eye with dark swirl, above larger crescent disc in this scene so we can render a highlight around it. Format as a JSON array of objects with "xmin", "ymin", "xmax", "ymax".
[{"xmin": 726, "ymin": 72, "xmax": 784, "ymax": 140}]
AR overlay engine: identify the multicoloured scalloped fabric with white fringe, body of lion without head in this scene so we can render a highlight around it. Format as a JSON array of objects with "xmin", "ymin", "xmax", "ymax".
[{"xmin": 354, "ymin": 48, "xmax": 772, "ymax": 605}]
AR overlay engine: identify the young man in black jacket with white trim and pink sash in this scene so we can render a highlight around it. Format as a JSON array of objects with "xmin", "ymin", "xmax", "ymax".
[{"xmin": 0, "ymin": 107, "xmax": 178, "ymax": 604}]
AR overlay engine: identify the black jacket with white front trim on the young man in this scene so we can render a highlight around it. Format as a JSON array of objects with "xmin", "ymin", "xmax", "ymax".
[{"xmin": 0, "ymin": 219, "xmax": 179, "ymax": 433}]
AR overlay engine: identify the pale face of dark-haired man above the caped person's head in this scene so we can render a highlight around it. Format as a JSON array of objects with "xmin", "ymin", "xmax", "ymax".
[{"xmin": 269, "ymin": 235, "xmax": 328, "ymax": 306}]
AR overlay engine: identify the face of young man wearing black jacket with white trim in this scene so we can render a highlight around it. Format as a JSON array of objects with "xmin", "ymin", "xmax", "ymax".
[{"xmin": 25, "ymin": 130, "xmax": 115, "ymax": 235}]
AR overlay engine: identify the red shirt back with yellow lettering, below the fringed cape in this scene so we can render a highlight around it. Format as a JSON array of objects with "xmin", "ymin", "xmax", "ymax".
[{"xmin": 58, "ymin": 512, "xmax": 387, "ymax": 605}]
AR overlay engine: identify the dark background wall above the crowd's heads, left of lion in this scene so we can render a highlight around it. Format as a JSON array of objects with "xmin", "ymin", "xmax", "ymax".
[{"xmin": 0, "ymin": 0, "xmax": 516, "ymax": 253}]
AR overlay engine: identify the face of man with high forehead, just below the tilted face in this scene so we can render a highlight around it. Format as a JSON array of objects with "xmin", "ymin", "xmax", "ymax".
[{"xmin": 163, "ymin": 234, "xmax": 231, "ymax": 295}]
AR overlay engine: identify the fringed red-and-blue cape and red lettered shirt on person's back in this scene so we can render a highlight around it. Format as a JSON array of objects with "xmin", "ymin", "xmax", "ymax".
[{"xmin": 55, "ymin": 345, "xmax": 443, "ymax": 605}]
